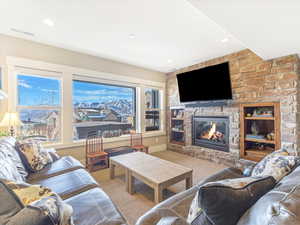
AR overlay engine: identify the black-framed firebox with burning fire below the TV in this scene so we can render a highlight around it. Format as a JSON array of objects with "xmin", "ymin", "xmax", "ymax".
[{"xmin": 192, "ymin": 116, "xmax": 229, "ymax": 152}]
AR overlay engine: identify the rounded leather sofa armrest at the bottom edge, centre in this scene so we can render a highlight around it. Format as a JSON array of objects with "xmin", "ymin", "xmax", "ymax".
[{"xmin": 136, "ymin": 208, "xmax": 189, "ymax": 225}]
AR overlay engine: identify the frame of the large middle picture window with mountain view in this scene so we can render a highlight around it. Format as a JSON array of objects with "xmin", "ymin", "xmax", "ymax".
[{"xmin": 72, "ymin": 78, "xmax": 139, "ymax": 142}]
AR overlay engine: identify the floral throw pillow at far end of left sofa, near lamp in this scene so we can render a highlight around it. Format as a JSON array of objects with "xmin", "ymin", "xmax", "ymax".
[{"xmin": 16, "ymin": 141, "xmax": 52, "ymax": 173}]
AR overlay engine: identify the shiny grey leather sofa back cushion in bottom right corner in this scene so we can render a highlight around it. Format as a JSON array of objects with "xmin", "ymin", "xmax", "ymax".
[{"xmin": 238, "ymin": 166, "xmax": 300, "ymax": 225}]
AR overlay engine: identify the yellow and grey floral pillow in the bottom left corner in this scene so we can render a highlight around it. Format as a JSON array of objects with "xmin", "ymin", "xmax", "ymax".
[{"xmin": 1, "ymin": 180, "xmax": 74, "ymax": 225}]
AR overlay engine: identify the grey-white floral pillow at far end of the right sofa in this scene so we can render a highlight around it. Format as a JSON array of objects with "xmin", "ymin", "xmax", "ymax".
[{"xmin": 251, "ymin": 150, "xmax": 297, "ymax": 182}]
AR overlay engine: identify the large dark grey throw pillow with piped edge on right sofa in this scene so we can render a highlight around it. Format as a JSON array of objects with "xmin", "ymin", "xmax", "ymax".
[{"xmin": 188, "ymin": 176, "xmax": 276, "ymax": 225}]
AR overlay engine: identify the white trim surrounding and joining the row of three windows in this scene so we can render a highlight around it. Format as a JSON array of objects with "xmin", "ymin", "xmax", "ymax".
[{"xmin": 6, "ymin": 56, "xmax": 166, "ymax": 148}]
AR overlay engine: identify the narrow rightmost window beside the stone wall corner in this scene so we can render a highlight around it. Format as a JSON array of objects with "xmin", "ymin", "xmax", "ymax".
[{"xmin": 145, "ymin": 88, "xmax": 160, "ymax": 131}]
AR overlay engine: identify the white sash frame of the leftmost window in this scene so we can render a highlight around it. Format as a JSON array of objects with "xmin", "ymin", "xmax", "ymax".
[{"xmin": 14, "ymin": 68, "xmax": 64, "ymax": 145}]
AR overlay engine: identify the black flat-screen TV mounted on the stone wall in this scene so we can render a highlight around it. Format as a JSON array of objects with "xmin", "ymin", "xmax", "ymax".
[{"xmin": 177, "ymin": 62, "xmax": 232, "ymax": 102}]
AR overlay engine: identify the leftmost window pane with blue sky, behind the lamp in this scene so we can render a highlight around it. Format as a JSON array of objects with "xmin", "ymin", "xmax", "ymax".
[{"xmin": 17, "ymin": 74, "xmax": 61, "ymax": 142}]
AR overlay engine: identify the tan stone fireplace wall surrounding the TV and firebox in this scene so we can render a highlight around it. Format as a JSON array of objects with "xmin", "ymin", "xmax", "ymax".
[{"xmin": 167, "ymin": 50, "xmax": 300, "ymax": 166}]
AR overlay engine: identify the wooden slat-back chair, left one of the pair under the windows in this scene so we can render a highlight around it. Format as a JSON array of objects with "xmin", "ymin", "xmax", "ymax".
[{"xmin": 85, "ymin": 135, "xmax": 108, "ymax": 172}]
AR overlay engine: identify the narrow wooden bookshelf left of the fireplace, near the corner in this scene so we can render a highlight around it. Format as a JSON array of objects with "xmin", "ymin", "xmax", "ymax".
[{"xmin": 170, "ymin": 107, "xmax": 185, "ymax": 145}]
